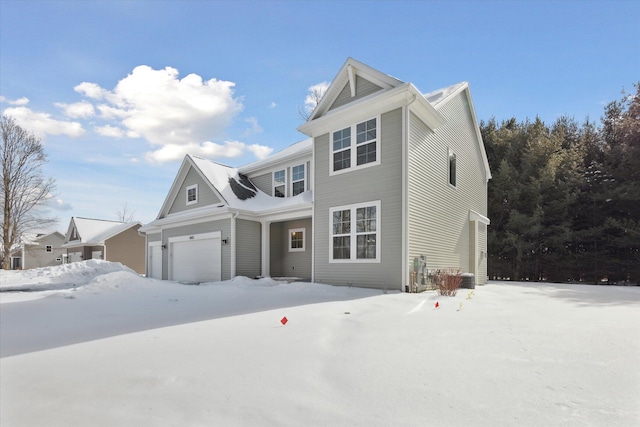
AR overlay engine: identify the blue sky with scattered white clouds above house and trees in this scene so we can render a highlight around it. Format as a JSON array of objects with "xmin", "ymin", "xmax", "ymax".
[{"xmin": 0, "ymin": 0, "xmax": 640, "ymax": 232}]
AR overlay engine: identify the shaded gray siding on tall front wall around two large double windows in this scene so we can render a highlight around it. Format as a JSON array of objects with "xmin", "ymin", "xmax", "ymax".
[{"xmin": 314, "ymin": 109, "xmax": 403, "ymax": 290}]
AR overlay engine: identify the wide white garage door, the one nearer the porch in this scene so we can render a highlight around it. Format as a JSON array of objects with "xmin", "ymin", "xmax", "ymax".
[{"xmin": 169, "ymin": 231, "xmax": 222, "ymax": 282}]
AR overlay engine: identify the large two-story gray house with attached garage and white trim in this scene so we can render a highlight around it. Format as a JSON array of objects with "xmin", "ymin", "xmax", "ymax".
[{"xmin": 140, "ymin": 58, "xmax": 491, "ymax": 290}]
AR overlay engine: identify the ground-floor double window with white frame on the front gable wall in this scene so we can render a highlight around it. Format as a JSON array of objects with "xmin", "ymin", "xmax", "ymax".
[{"xmin": 329, "ymin": 200, "xmax": 380, "ymax": 262}]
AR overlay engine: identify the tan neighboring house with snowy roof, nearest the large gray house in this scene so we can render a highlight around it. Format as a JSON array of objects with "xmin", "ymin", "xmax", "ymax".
[{"xmin": 62, "ymin": 217, "xmax": 145, "ymax": 274}]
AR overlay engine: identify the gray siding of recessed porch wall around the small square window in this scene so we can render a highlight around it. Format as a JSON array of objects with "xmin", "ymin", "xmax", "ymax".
[{"xmin": 269, "ymin": 218, "xmax": 312, "ymax": 280}]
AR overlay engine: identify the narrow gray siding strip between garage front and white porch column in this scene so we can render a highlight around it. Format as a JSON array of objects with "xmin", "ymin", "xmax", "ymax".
[{"xmin": 236, "ymin": 219, "xmax": 262, "ymax": 278}]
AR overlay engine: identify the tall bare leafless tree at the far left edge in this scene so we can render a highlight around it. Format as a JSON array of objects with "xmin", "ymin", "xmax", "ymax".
[{"xmin": 0, "ymin": 116, "xmax": 56, "ymax": 270}]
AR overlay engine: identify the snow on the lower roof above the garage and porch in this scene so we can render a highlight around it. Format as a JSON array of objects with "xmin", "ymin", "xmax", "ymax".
[{"xmin": 189, "ymin": 155, "xmax": 311, "ymax": 212}]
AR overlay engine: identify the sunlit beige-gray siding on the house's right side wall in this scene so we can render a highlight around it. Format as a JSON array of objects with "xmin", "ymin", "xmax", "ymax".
[{"xmin": 407, "ymin": 93, "xmax": 487, "ymax": 282}]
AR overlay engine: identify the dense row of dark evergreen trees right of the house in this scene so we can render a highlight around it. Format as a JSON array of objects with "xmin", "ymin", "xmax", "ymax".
[{"xmin": 480, "ymin": 83, "xmax": 640, "ymax": 283}]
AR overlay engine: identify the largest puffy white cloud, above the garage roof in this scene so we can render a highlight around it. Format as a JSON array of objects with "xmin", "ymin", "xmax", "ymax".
[{"xmin": 75, "ymin": 65, "xmax": 242, "ymax": 151}]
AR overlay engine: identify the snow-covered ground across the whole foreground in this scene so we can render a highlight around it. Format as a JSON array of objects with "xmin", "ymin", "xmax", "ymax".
[{"xmin": 0, "ymin": 261, "xmax": 640, "ymax": 427}]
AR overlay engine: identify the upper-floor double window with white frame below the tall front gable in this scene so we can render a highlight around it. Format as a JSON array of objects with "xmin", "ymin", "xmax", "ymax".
[{"xmin": 331, "ymin": 118, "xmax": 380, "ymax": 173}]
